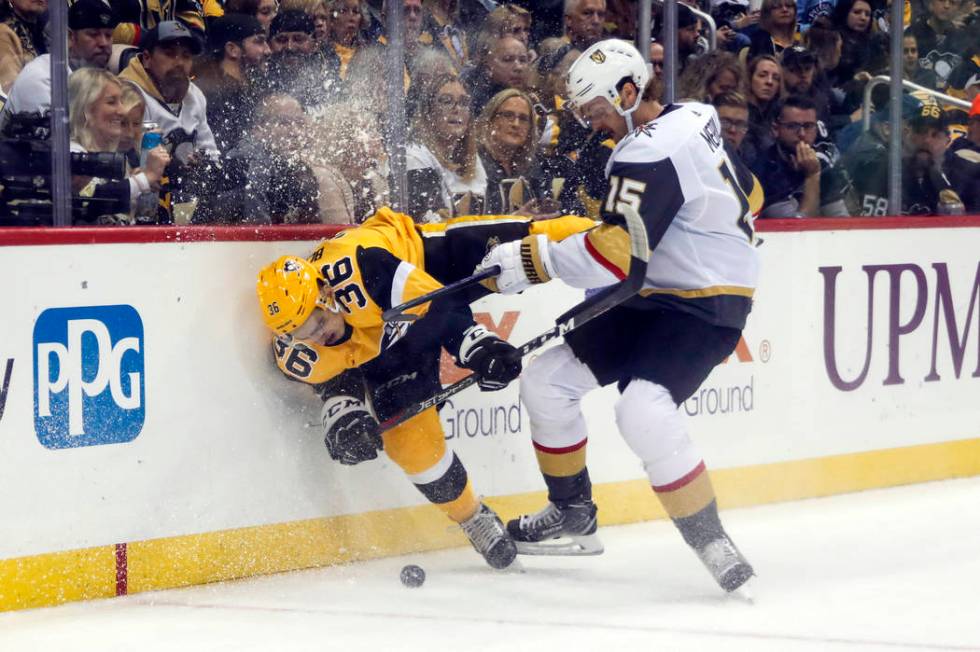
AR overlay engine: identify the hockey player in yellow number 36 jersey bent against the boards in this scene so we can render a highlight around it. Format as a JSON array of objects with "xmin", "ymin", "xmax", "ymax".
[{"xmin": 257, "ymin": 208, "xmax": 593, "ymax": 568}]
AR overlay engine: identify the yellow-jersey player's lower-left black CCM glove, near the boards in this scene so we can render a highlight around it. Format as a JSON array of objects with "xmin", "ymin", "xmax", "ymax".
[{"xmin": 320, "ymin": 395, "xmax": 382, "ymax": 464}]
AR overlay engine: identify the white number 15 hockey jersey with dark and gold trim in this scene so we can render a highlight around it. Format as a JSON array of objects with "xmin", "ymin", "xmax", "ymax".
[{"xmin": 549, "ymin": 102, "xmax": 762, "ymax": 328}]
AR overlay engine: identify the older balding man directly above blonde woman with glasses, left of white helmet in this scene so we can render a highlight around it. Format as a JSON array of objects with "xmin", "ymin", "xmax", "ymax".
[{"xmin": 464, "ymin": 35, "xmax": 528, "ymax": 115}]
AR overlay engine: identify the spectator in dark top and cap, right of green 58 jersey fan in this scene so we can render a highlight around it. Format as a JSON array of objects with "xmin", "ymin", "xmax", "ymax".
[{"xmin": 902, "ymin": 104, "xmax": 963, "ymax": 215}]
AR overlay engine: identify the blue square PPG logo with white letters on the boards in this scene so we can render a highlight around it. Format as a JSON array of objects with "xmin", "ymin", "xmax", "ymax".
[{"xmin": 34, "ymin": 306, "xmax": 146, "ymax": 448}]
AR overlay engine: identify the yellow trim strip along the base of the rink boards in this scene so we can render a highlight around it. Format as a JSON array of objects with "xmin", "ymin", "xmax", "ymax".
[{"xmin": 0, "ymin": 439, "xmax": 980, "ymax": 611}]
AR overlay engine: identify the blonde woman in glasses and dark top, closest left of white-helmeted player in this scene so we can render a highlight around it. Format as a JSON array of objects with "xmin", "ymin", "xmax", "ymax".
[{"xmin": 476, "ymin": 88, "xmax": 546, "ymax": 214}]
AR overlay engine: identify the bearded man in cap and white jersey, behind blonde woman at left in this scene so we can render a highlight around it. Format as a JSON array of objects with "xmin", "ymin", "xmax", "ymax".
[{"xmin": 119, "ymin": 20, "xmax": 219, "ymax": 158}]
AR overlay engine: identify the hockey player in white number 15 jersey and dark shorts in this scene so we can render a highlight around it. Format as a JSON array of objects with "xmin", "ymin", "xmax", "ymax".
[{"xmin": 478, "ymin": 39, "xmax": 762, "ymax": 591}]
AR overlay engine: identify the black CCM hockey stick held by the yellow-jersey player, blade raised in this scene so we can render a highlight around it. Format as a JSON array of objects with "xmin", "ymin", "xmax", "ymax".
[{"xmin": 380, "ymin": 206, "xmax": 650, "ymax": 430}]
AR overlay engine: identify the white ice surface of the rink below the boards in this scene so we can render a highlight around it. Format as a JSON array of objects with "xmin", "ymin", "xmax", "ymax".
[{"xmin": 0, "ymin": 478, "xmax": 980, "ymax": 652}]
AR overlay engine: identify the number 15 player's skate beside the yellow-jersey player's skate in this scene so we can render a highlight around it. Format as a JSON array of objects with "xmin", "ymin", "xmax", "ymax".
[{"xmin": 507, "ymin": 500, "xmax": 603, "ymax": 555}]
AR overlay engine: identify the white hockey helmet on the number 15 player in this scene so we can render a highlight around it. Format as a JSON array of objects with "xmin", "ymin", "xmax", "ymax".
[{"xmin": 566, "ymin": 38, "xmax": 651, "ymax": 130}]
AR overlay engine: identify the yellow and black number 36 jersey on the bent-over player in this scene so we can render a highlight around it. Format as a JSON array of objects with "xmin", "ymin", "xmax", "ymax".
[{"xmin": 274, "ymin": 208, "xmax": 595, "ymax": 384}]
